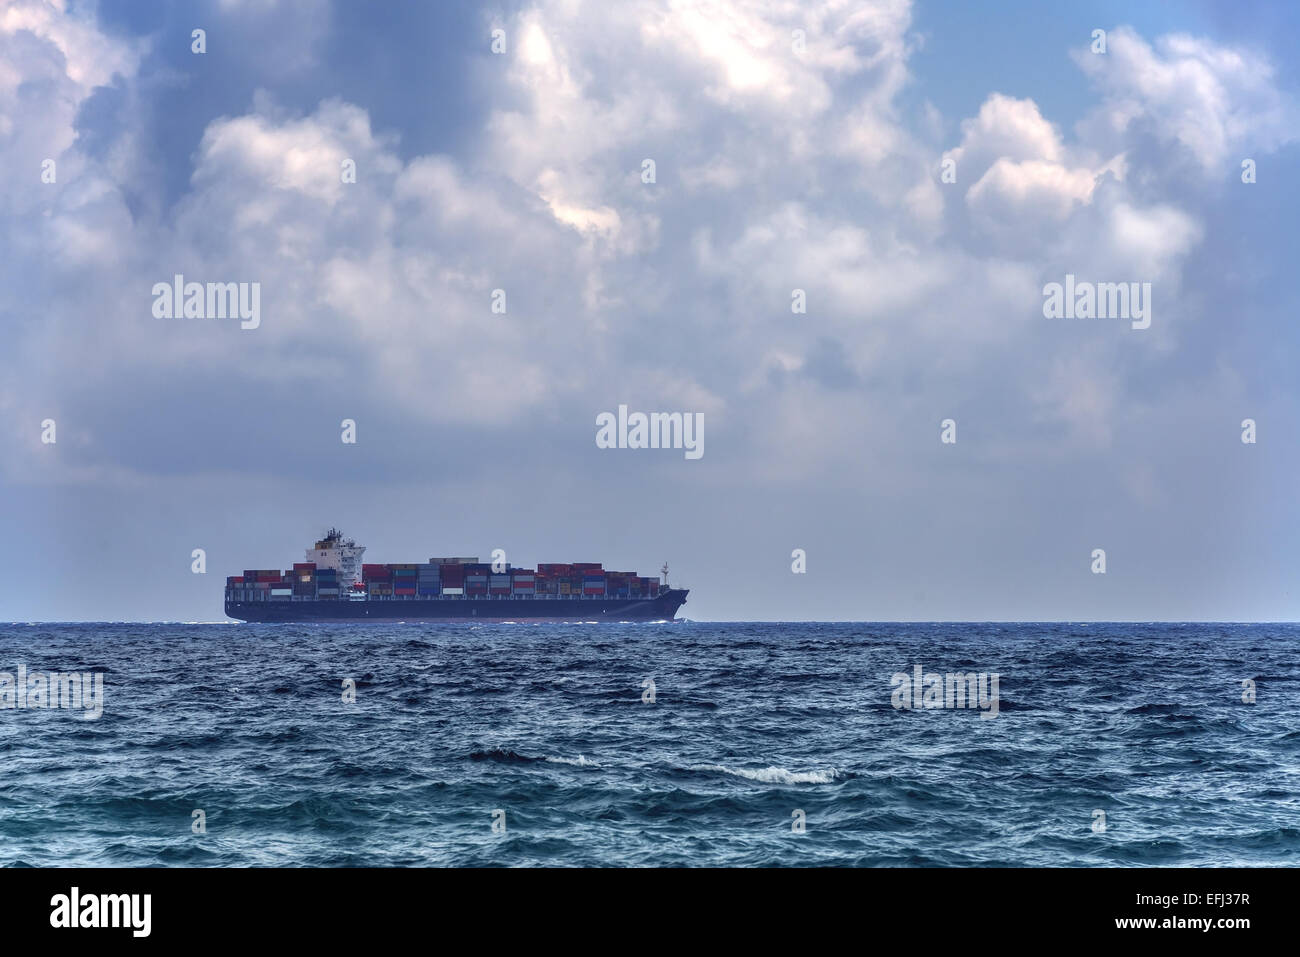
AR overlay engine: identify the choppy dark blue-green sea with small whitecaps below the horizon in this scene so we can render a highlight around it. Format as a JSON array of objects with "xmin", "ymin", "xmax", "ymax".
[{"xmin": 0, "ymin": 622, "xmax": 1300, "ymax": 867}]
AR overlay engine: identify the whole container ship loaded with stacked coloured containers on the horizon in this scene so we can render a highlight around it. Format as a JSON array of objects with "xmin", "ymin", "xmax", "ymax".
[{"xmin": 225, "ymin": 528, "xmax": 688, "ymax": 622}]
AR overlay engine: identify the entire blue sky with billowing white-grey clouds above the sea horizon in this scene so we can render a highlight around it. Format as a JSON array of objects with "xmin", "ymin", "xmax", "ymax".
[{"xmin": 0, "ymin": 0, "xmax": 1300, "ymax": 622}]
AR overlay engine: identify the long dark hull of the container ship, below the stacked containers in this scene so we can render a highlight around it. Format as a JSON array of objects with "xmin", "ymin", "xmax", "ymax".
[{"xmin": 226, "ymin": 588, "xmax": 688, "ymax": 623}]
